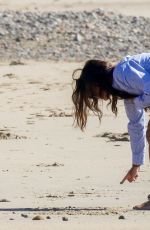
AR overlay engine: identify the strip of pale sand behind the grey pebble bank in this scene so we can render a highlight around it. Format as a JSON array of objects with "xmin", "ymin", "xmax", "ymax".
[{"xmin": 0, "ymin": 0, "xmax": 150, "ymax": 17}]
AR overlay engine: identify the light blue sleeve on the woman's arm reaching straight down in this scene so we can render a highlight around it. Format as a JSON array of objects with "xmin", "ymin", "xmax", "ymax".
[{"xmin": 124, "ymin": 99, "xmax": 146, "ymax": 165}]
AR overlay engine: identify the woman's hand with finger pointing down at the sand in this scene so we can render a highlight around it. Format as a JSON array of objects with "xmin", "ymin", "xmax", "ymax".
[{"xmin": 120, "ymin": 165, "xmax": 140, "ymax": 184}]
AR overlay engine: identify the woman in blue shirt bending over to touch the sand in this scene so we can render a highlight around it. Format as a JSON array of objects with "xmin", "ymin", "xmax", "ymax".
[{"xmin": 72, "ymin": 53, "xmax": 150, "ymax": 209}]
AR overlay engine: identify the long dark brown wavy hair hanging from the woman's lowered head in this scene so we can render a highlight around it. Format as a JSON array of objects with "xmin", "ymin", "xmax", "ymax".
[{"xmin": 72, "ymin": 60, "xmax": 137, "ymax": 130}]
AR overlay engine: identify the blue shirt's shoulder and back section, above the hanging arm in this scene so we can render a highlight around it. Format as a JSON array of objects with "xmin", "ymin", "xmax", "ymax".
[{"xmin": 113, "ymin": 54, "xmax": 150, "ymax": 95}]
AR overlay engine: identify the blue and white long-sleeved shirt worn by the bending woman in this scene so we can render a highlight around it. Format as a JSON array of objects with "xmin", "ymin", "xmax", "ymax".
[{"xmin": 113, "ymin": 53, "xmax": 150, "ymax": 165}]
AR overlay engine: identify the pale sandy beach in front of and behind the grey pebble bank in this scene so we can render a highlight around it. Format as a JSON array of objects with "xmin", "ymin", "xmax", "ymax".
[{"xmin": 0, "ymin": 0, "xmax": 150, "ymax": 230}]
